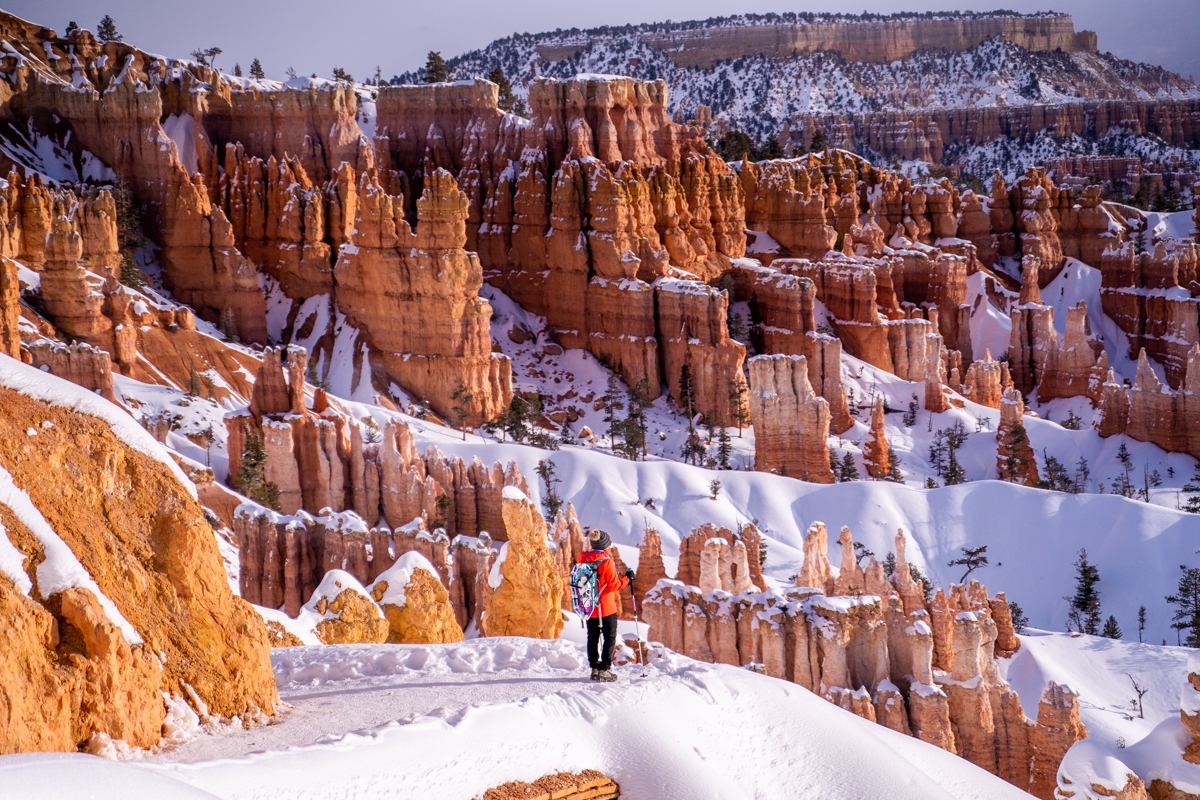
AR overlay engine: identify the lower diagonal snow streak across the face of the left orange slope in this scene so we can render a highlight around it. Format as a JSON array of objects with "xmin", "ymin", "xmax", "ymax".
[{"xmin": 0, "ymin": 462, "xmax": 142, "ymax": 644}]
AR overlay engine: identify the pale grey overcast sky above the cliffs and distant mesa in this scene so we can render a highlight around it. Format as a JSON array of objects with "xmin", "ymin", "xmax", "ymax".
[{"xmin": 11, "ymin": 0, "xmax": 1200, "ymax": 79}]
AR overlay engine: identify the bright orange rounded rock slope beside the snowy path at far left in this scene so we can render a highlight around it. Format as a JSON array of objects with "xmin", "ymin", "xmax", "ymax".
[{"xmin": 0, "ymin": 360, "xmax": 276, "ymax": 752}]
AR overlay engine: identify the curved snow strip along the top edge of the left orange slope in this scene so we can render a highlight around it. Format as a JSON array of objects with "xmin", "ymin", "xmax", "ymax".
[{"xmin": 0, "ymin": 359, "xmax": 196, "ymax": 498}]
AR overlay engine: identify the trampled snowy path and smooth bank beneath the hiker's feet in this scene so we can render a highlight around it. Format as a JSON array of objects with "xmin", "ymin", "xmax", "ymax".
[{"xmin": 133, "ymin": 638, "xmax": 1027, "ymax": 800}]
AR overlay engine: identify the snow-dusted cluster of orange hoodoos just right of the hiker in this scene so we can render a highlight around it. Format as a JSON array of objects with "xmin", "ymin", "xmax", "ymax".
[{"xmin": 643, "ymin": 523, "xmax": 1086, "ymax": 799}]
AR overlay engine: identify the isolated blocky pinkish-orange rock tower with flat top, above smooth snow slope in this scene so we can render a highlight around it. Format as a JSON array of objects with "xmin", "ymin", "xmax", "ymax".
[{"xmin": 749, "ymin": 355, "xmax": 834, "ymax": 483}]
